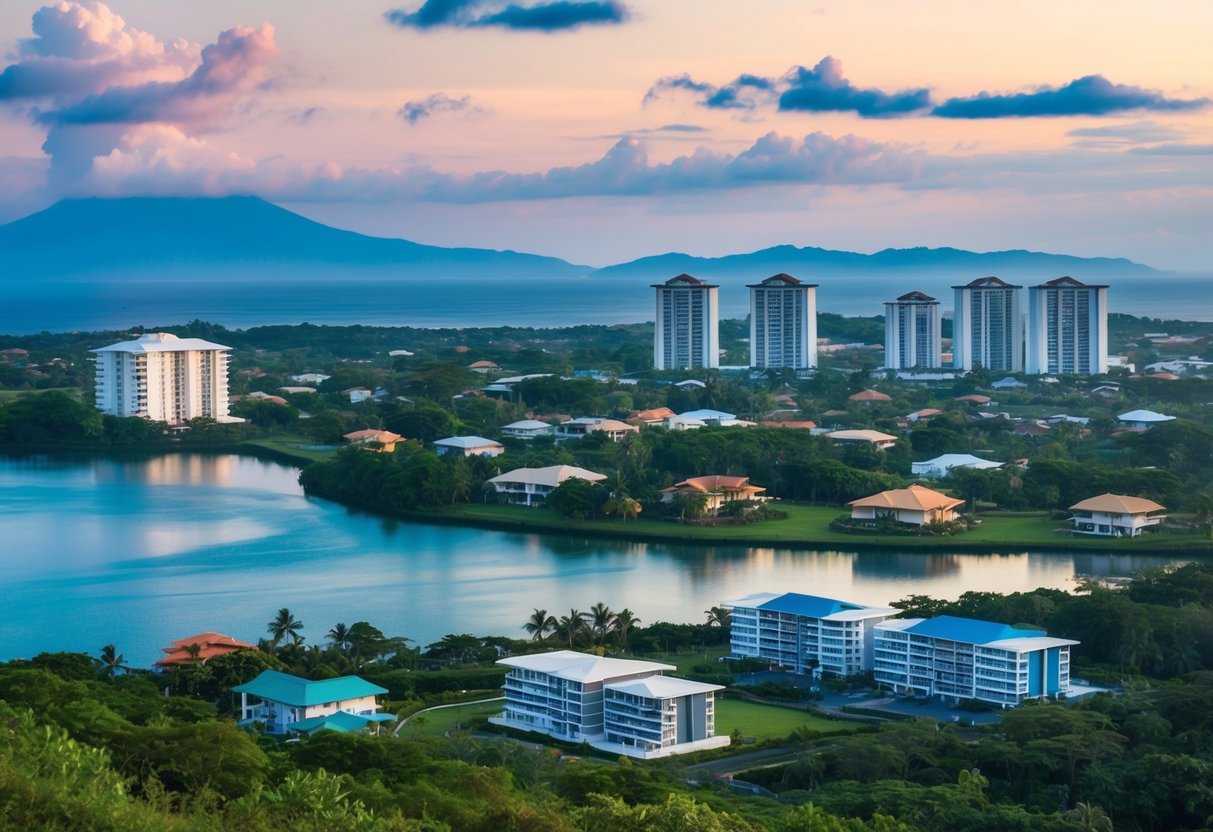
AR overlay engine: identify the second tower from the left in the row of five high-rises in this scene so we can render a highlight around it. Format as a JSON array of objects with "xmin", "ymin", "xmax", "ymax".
[{"xmin": 747, "ymin": 273, "xmax": 818, "ymax": 370}]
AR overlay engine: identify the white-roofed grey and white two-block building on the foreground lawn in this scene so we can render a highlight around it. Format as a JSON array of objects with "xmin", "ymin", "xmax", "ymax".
[{"xmin": 489, "ymin": 650, "xmax": 729, "ymax": 758}]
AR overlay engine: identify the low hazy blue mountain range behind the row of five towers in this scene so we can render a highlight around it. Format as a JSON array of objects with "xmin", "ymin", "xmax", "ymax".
[{"xmin": 594, "ymin": 245, "xmax": 1163, "ymax": 283}]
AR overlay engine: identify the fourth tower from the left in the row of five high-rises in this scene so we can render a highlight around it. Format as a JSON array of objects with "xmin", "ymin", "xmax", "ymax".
[{"xmin": 952, "ymin": 278, "xmax": 1024, "ymax": 372}]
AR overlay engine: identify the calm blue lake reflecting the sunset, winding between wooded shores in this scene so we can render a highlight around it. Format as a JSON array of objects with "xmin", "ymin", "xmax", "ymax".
[{"xmin": 0, "ymin": 454, "xmax": 1172, "ymax": 666}]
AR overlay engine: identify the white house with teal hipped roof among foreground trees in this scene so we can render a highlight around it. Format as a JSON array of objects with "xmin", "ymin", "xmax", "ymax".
[{"xmin": 232, "ymin": 671, "xmax": 395, "ymax": 734}]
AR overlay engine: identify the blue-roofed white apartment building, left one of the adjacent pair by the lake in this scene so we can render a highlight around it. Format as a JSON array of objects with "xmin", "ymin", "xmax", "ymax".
[{"xmin": 725, "ymin": 592, "xmax": 896, "ymax": 676}]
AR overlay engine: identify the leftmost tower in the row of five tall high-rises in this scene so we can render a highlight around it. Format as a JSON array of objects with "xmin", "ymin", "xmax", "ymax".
[{"xmin": 653, "ymin": 274, "xmax": 721, "ymax": 370}]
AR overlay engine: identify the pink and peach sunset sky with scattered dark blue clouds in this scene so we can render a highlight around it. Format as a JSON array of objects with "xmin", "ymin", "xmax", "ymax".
[{"xmin": 0, "ymin": 0, "xmax": 1213, "ymax": 266}]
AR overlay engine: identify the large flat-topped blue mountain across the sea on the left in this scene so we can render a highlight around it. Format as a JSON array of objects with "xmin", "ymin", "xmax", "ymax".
[{"xmin": 0, "ymin": 196, "xmax": 592, "ymax": 280}]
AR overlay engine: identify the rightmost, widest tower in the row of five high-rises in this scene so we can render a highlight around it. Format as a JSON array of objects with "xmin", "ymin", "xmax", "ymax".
[{"xmin": 1025, "ymin": 278, "xmax": 1107, "ymax": 376}]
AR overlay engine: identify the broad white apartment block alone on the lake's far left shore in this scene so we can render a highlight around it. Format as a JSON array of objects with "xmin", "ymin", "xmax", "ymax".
[{"xmin": 92, "ymin": 332, "xmax": 244, "ymax": 424}]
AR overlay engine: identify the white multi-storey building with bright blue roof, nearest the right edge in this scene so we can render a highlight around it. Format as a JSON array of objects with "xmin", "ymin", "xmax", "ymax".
[{"xmin": 872, "ymin": 615, "xmax": 1078, "ymax": 707}]
